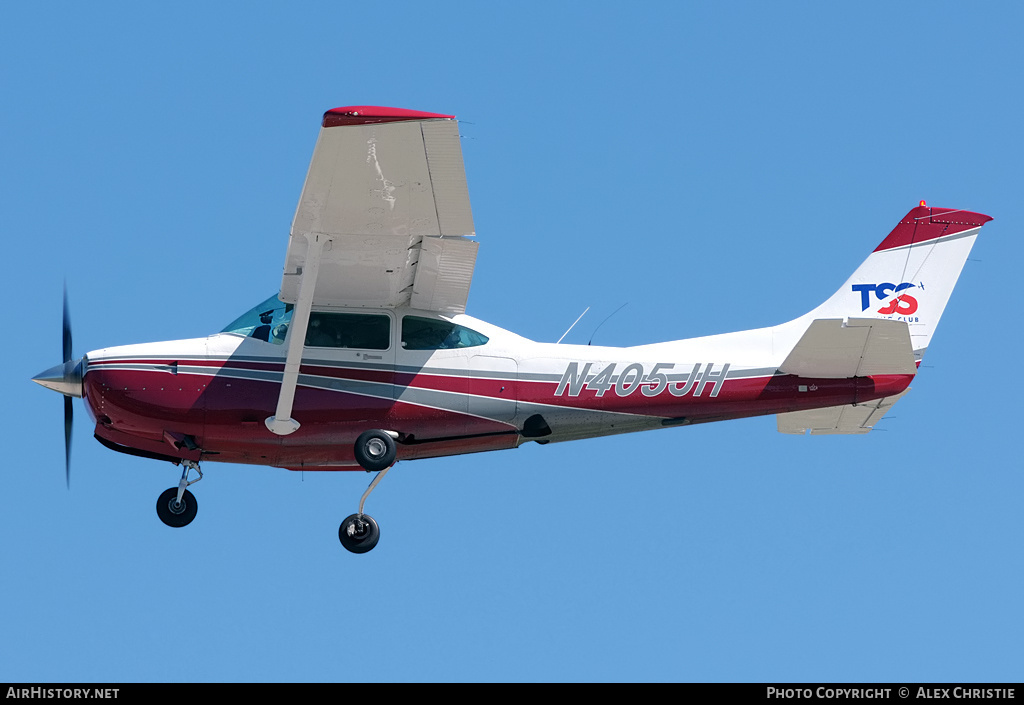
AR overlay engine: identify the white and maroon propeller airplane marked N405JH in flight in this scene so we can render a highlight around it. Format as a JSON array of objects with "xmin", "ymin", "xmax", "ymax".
[{"xmin": 34, "ymin": 106, "xmax": 991, "ymax": 553}]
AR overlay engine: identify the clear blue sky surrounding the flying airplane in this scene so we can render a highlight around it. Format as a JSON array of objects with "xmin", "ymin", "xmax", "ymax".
[{"xmin": 0, "ymin": 2, "xmax": 1024, "ymax": 681}]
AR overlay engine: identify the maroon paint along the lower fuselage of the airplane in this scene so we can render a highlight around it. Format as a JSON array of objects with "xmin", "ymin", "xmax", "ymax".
[{"xmin": 84, "ymin": 359, "xmax": 913, "ymax": 470}]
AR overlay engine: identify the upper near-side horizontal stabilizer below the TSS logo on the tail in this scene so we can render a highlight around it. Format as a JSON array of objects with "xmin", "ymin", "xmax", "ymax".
[{"xmin": 779, "ymin": 319, "xmax": 918, "ymax": 379}]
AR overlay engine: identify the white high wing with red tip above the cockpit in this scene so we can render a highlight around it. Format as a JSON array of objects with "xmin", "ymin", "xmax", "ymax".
[{"xmin": 281, "ymin": 106, "xmax": 477, "ymax": 315}]
